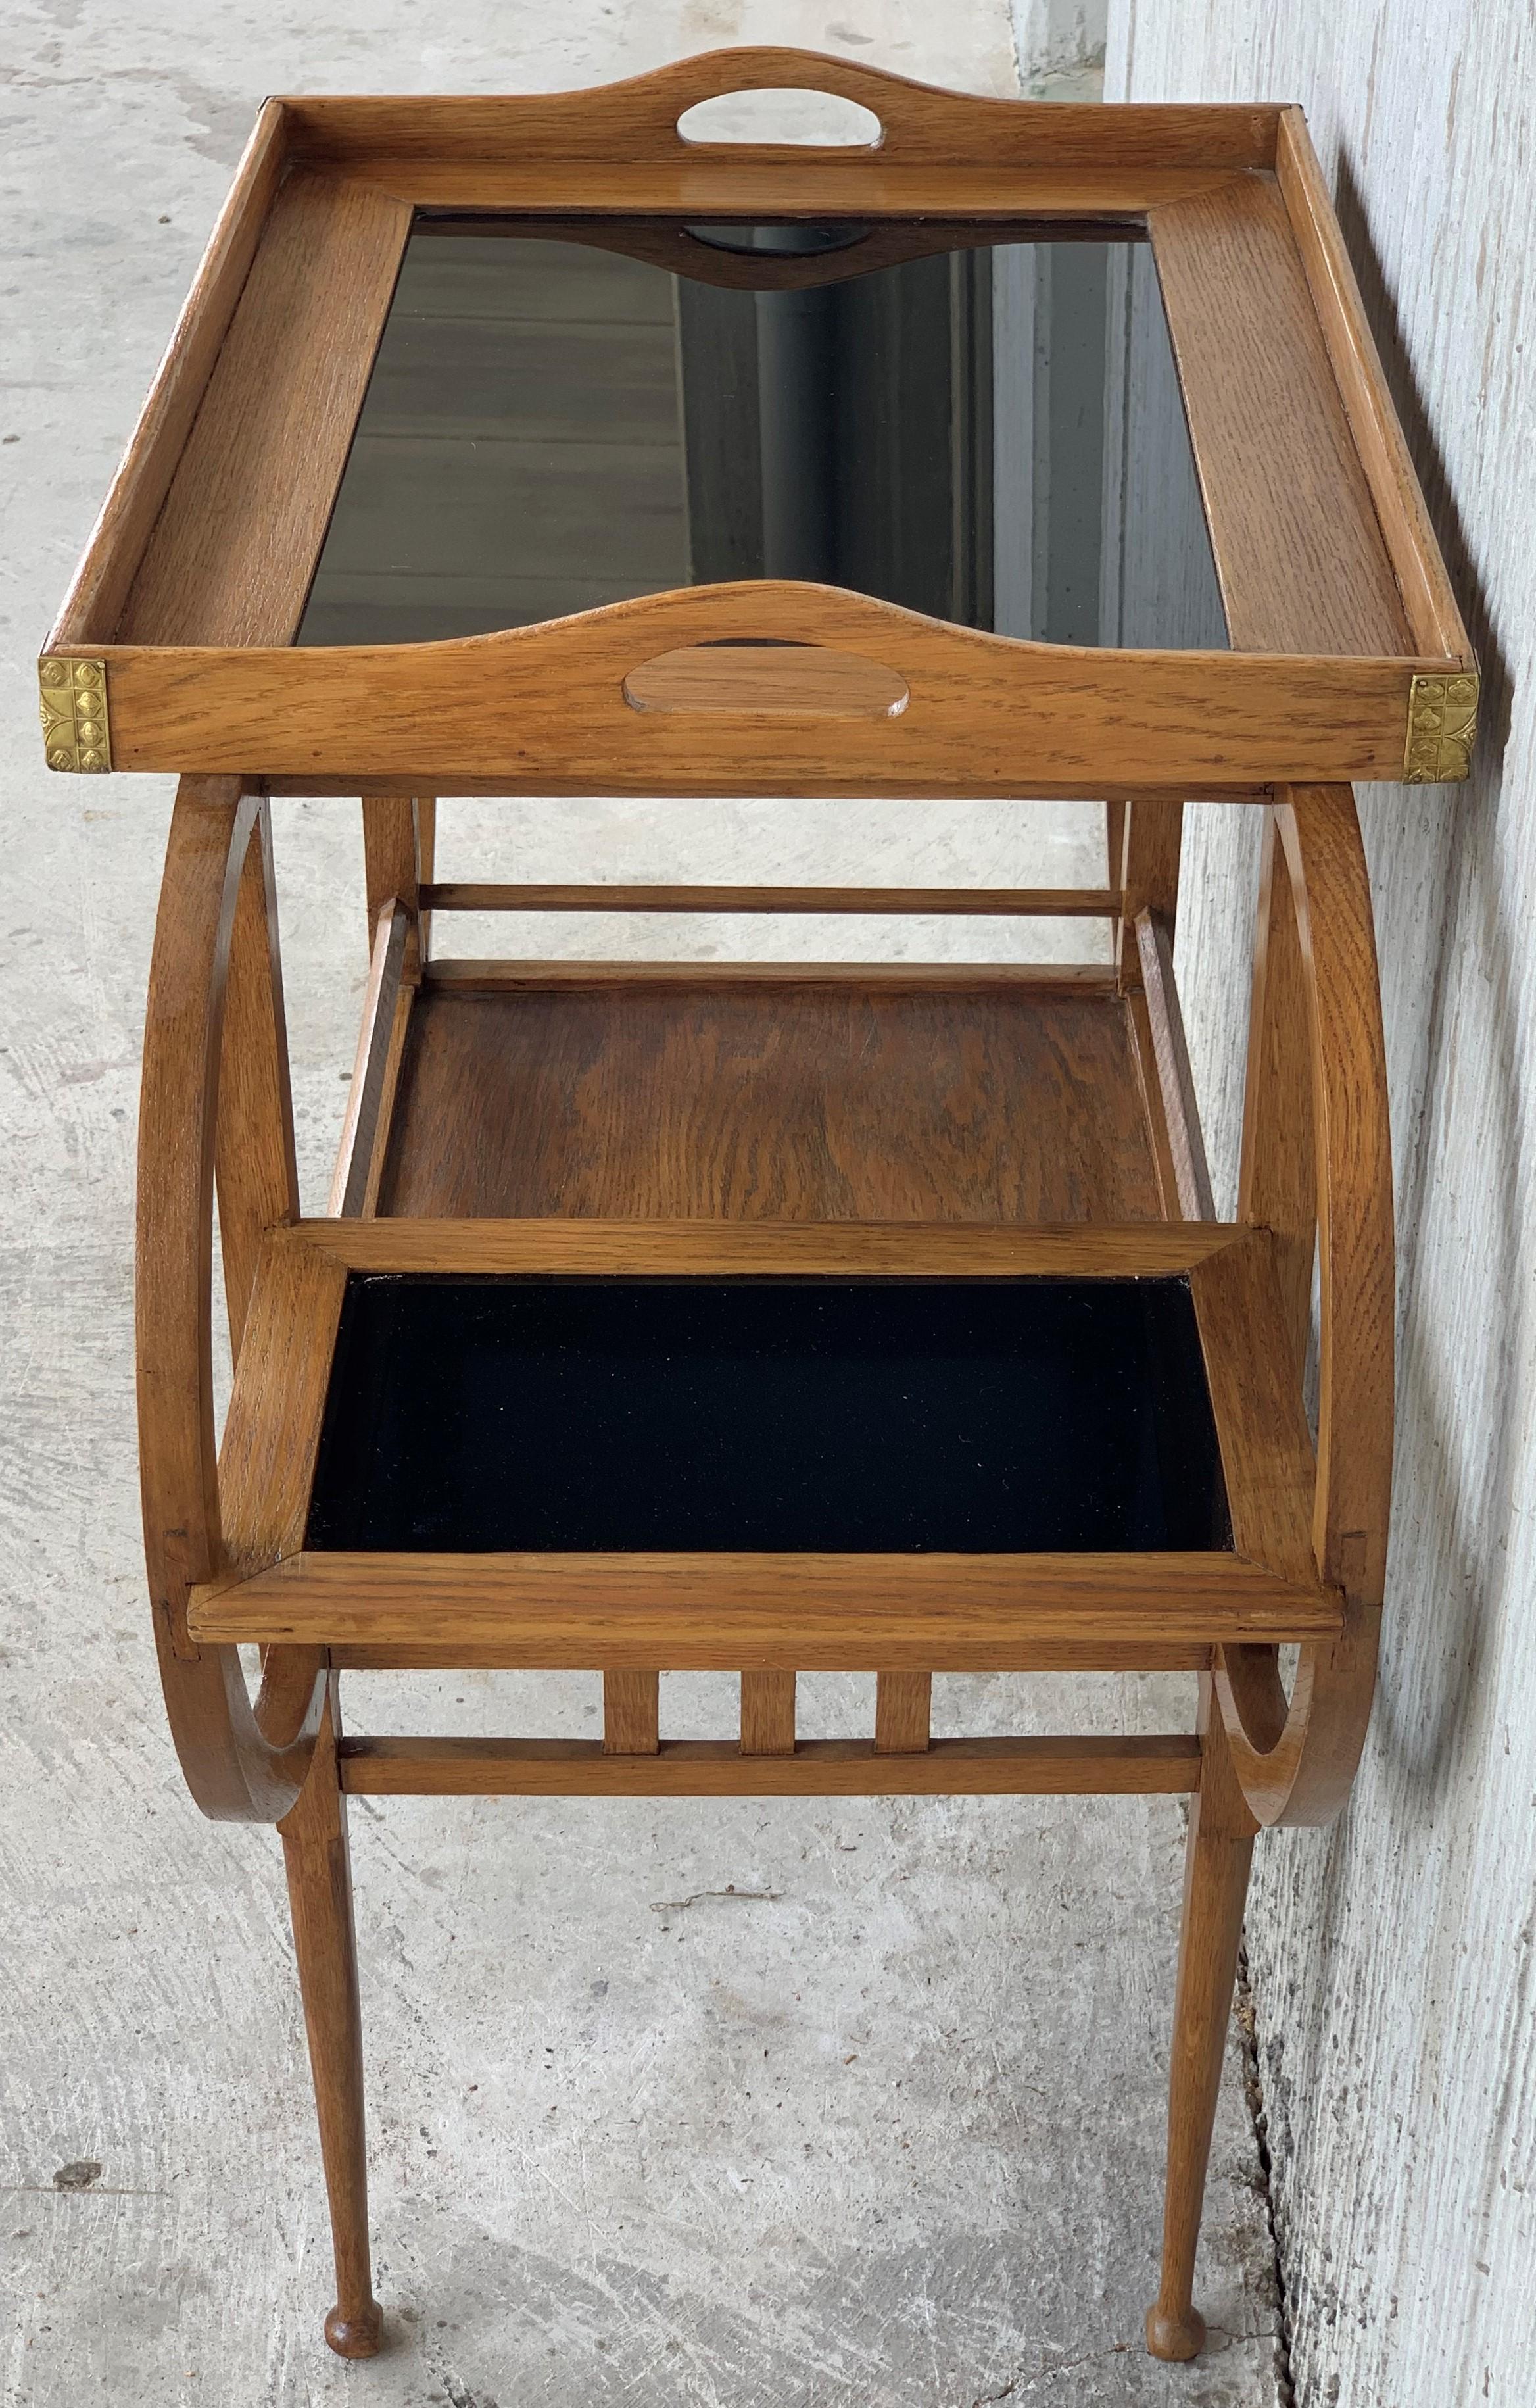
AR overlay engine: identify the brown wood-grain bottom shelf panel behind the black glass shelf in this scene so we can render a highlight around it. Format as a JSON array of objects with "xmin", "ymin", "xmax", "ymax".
[{"xmin": 378, "ymin": 973, "xmax": 1158, "ymax": 1221}]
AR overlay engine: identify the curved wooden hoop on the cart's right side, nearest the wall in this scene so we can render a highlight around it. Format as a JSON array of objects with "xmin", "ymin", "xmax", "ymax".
[{"xmin": 1216, "ymin": 785, "xmax": 1394, "ymax": 1823}]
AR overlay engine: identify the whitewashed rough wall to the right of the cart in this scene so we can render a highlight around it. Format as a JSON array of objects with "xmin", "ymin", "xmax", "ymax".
[{"xmin": 1107, "ymin": 0, "xmax": 1536, "ymax": 2408}]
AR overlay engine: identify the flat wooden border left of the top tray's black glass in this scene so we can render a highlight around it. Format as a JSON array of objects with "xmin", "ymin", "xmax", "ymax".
[{"xmin": 113, "ymin": 174, "xmax": 409, "ymax": 650}]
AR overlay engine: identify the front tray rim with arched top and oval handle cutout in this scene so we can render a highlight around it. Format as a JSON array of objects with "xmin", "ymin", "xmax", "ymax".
[{"xmin": 84, "ymin": 592, "xmax": 1445, "ymax": 799}]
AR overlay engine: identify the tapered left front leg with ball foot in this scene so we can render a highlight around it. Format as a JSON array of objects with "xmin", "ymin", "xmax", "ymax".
[{"xmin": 277, "ymin": 1681, "xmax": 383, "ymax": 2357}]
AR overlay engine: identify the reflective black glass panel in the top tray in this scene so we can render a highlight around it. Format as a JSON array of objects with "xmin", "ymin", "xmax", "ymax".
[{"xmin": 299, "ymin": 216, "xmax": 1226, "ymax": 648}]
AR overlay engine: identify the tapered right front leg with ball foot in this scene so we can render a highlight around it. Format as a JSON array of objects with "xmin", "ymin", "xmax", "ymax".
[{"xmin": 1146, "ymin": 1673, "xmax": 1257, "ymax": 2357}]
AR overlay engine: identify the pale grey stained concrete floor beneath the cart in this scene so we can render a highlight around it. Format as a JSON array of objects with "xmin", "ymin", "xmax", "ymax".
[{"xmin": 0, "ymin": 0, "xmax": 1278, "ymax": 2408}]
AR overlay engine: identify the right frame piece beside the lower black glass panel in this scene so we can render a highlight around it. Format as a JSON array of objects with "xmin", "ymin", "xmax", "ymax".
[{"xmin": 1189, "ymin": 1231, "xmax": 1317, "ymax": 1587}]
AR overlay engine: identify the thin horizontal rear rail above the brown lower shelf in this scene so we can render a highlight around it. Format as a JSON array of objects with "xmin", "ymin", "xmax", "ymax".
[{"xmin": 421, "ymin": 881, "xmax": 1120, "ymax": 920}]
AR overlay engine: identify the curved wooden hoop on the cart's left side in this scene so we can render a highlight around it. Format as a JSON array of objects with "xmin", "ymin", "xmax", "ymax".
[{"xmin": 135, "ymin": 778, "xmax": 325, "ymax": 1823}]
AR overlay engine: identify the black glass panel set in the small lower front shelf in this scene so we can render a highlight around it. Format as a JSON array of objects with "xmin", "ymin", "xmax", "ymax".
[{"xmin": 306, "ymin": 1271, "xmax": 1230, "ymax": 1553}]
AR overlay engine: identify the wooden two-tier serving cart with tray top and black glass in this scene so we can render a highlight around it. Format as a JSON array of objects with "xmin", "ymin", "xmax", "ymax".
[{"xmin": 41, "ymin": 51, "xmax": 1476, "ymax": 2357}]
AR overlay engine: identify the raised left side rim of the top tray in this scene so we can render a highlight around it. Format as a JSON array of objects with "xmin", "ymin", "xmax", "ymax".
[{"xmin": 48, "ymin": 101, "xmax": 287, "ymax": 650}]
